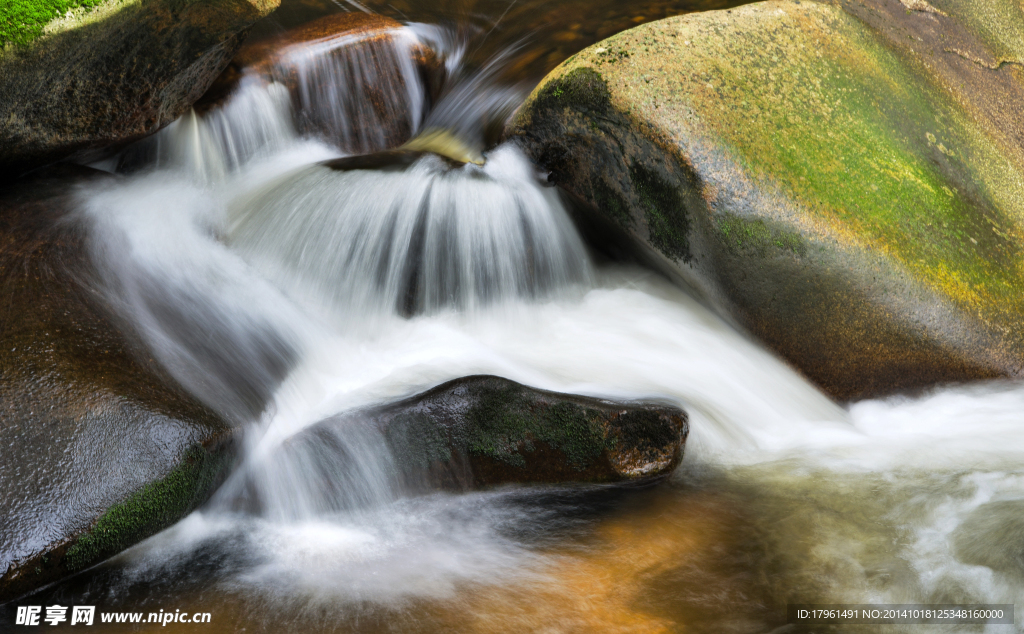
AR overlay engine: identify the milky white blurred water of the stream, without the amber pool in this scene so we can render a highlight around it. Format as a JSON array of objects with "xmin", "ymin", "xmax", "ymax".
[{"xmin": 74, "ymin": 17, "xmax": 1024, "ymax": 631}]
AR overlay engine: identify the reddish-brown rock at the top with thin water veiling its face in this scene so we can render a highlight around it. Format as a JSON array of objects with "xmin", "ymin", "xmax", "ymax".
[{"xmin": 196, "ymin": 12, "xmax": 444, "ymax": 153}]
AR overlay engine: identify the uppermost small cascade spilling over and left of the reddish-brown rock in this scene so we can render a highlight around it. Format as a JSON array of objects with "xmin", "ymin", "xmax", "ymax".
[{"xmin": 128, "ymin": 21, "xmax": 428, "ymax": 183}]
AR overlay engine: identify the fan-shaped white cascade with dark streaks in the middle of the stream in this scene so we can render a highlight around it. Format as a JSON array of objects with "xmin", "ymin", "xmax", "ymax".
[{"xmin": 227, "ymin": 146, "xmax": 591, "ymax": 318}]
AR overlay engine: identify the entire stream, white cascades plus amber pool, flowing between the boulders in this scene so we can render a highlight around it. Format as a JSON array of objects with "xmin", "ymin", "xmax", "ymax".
[{"xmin": 29, "ymin": 6, "xmax": 1024, "ymax": 633}]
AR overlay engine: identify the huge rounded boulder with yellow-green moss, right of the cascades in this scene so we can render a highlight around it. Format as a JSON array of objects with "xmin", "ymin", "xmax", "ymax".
[{"xmin": 507, "ymin": 0, "xmax": 1024, "ymax": 399}]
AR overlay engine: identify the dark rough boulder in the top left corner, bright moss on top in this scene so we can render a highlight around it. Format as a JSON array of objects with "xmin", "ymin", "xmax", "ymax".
[{"xmin": 0, "ymin": 0, "xmax": 280, "ymax": 176}]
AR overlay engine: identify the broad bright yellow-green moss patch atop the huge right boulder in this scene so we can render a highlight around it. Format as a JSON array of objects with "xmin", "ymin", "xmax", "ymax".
[{"xmin": 649, "ymin": 5, "xmax": 1024, "ymax": 319}]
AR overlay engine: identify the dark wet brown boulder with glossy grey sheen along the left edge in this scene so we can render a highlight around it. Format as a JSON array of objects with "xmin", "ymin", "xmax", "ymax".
[{"xmin": 0, "ymin": 166, "xmax": 234, "ymax": 603}]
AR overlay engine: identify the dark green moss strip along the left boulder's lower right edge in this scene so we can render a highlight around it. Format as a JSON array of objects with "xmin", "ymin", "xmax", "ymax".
[{"xmin": 65, "ymin": 448, "xmax": 225, "ymax": 573}]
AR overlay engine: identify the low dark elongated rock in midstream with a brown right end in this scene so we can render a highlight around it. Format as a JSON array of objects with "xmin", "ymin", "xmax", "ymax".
[{"xmin": 300, "ymin": 376, "xmax": 689, "ymax": 491}]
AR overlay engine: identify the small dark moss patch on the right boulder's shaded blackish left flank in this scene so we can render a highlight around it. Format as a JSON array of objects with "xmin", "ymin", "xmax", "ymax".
[{"xmin": 630, "ymin": 161, "xmax": 692, "ymax": 262}]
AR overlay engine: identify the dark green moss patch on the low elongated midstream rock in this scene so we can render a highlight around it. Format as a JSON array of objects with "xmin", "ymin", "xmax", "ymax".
[{"xmin": 466, "ymin": 384, "xmax": 609, "ymax": 471}]
